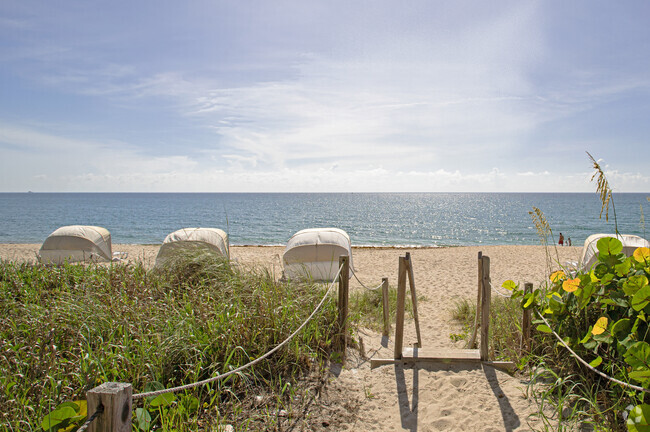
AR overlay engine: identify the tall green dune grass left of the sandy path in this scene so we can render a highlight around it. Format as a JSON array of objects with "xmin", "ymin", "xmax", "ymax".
[{"xmin": 0, "ymin": 255, "xmax": 344, "ymax": 431}]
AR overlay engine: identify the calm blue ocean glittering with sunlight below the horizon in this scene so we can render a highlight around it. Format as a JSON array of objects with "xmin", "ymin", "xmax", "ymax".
[{"xmin": 0, "ymin": 193, "xmax": 650, "ymax": 247}]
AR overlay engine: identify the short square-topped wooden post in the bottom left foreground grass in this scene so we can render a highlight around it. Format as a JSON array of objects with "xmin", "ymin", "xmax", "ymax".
[{"xmin": 86, "ymin": 382, "xmax": 133, "ymax": 432}]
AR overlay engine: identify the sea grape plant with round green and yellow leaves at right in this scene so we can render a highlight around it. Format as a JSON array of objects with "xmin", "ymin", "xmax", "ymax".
[{"xmin": 507, "ymin": 237, "xmax": 650, "ymax": 430}]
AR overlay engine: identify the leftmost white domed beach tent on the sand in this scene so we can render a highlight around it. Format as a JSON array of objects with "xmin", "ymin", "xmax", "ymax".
[{"xmin": 38, "ymin": 225, "xmax": 112, "ymax": 264}]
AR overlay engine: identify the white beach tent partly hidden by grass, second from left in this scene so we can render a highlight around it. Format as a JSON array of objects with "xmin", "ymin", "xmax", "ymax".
[{"xmin": 155, "ymin": 228, "xmax": 229, "ymax": 267}]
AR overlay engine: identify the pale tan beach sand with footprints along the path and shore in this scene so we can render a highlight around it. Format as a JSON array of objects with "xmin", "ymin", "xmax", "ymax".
[{"xmin": 0, "ymin": 244, "xmax": 581, "ymax": 432}]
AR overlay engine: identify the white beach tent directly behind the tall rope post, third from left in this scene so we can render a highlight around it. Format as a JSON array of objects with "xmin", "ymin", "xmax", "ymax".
[{"xmin": 282, "ymin": 228, "xmax": 354, "ymax": 282}]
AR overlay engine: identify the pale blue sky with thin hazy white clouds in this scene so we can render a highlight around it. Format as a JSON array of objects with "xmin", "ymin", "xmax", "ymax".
[{"xmin": 0, "ymin": 0, "xmax": 650, "ymax": 192}]
